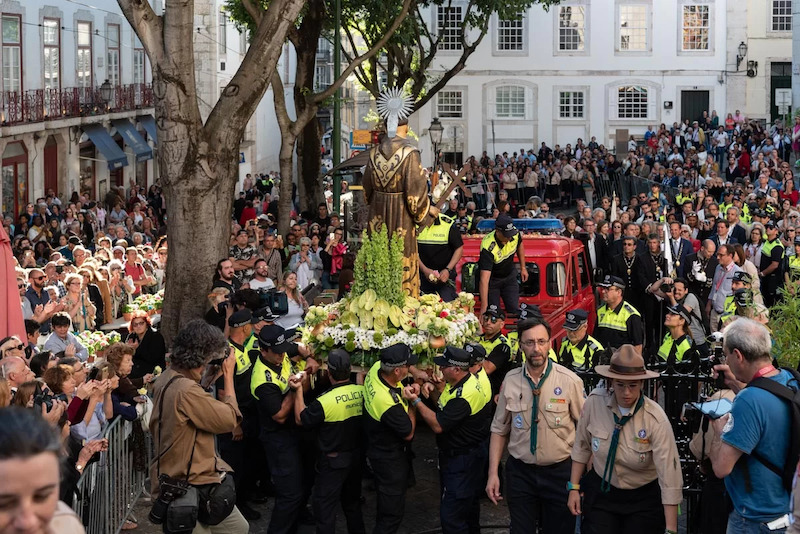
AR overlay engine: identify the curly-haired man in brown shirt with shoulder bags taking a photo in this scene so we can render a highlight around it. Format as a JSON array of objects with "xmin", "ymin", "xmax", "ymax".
[{"xmin": 150, "ymin": 320, "xmax": 249, "ymax": 534}]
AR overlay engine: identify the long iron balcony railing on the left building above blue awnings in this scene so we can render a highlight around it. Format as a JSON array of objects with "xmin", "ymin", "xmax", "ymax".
[{"xmin": 0, "ymin": 83, "xmax": 153, "ymax": 126}]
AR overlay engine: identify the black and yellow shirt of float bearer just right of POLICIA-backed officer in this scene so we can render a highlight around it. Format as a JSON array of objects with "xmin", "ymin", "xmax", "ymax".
[{"xmin": 364, "ymin": 361, "xmax": 414, "ymax": 458}]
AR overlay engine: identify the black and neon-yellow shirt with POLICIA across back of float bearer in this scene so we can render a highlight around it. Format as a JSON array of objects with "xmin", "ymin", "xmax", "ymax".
[{"xmin": 300, "ymin": 382, "xmax": 364, "ymax": 454}]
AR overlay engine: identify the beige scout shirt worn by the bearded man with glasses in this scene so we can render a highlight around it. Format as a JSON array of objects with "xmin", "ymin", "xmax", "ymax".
[{"xmin": 491, "ymin": 360, "xmax": 584, "ymax": 465}]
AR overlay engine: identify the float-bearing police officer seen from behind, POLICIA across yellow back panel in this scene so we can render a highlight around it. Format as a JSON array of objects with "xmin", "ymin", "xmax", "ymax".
[{"xmin": 289, "ymin": 349, "xmax": 366, "ymax": 534}]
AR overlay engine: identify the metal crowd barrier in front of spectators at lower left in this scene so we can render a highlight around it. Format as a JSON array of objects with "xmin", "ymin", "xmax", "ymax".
[{"xmin": 72, "ymin": 417, "xmax": 152, "ymax": 534}]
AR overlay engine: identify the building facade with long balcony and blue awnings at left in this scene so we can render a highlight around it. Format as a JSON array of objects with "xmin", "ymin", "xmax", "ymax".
[{"xmin": 0, "ymin": 0, "xmax": 157, "ymax": 218}]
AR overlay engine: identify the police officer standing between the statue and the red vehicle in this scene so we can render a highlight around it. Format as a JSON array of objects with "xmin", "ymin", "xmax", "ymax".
[{"xmin": 417, "ymin": 214, "xmax": 464, "ymax": 302}]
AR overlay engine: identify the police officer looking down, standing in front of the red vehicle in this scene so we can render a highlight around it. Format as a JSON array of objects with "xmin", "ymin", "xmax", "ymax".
[{"xmin": 478, "ymin": 213, "xmax": 528, "ymax": 314}]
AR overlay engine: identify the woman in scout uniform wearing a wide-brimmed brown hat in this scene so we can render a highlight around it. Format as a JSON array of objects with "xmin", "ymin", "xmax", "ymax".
[{"xmin": 567, "ymin": 345, "xmax": 683, "ymax": 534}]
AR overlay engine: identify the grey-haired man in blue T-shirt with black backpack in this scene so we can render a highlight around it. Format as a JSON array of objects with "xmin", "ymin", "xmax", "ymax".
[{"xmin": 710, "ymin": 318, "xmax": 800, "ymax": 533}]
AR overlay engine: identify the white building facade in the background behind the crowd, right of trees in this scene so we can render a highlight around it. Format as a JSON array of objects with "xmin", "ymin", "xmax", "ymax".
[{"xmin": 412, "ymin": 0, "xmax": 728, "ymax": 163}]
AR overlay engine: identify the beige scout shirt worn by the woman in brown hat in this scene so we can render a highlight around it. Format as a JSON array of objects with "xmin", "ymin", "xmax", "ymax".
[{"xmin": 572, "ymin": 388, "xmax": 683, "ymax": 504}]
